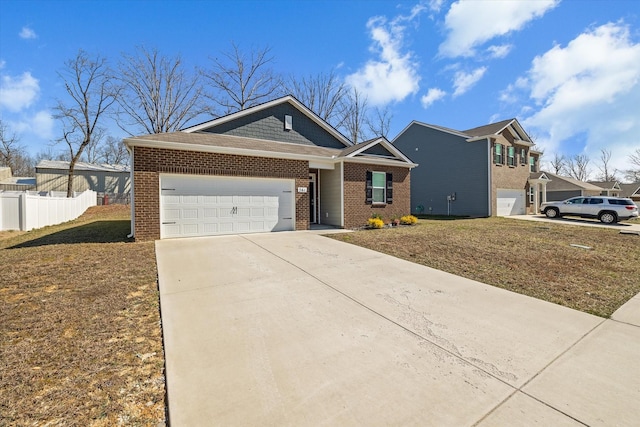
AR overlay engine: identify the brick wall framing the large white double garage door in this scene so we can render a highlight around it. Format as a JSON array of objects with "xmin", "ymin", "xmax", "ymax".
[{"xmin": 133, "ymin": 147, "xmax": 309, "ymax": 240}]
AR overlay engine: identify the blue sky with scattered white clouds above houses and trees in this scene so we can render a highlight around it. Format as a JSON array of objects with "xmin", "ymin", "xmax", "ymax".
[{"xmin": 0, "ymin": 0, "xmax": 640, "ymax": 178}]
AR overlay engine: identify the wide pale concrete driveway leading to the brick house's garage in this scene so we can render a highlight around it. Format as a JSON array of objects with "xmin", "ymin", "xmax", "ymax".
[{"xmin": 156, "ymin": 232, "xmax": 640, "ymax": 427}]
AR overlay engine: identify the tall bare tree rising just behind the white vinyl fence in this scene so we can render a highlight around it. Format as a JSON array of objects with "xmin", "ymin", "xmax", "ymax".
[{"xmin": 54, "ymin": 50, "xmax": 118, "ymax": 197}]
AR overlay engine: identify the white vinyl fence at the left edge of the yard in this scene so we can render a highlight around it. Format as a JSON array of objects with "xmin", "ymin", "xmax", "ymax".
[{"xmin": 0, "ymin": 190, "xmax": 97, "ymax": 231}]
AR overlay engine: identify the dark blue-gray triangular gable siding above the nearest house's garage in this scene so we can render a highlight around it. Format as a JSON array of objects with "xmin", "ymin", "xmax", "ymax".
[{"xmin": 206, "ymin": 103, "xmax": 345, "ymax": 148}]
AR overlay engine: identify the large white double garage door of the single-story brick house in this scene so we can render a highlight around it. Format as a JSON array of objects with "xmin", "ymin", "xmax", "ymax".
[{"xmin": 160, "ymin": 175, "xmax": 295, "ymax": 239}]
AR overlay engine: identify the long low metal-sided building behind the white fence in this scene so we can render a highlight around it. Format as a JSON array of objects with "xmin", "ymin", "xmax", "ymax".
[{"xmin": 36, "ymin": 160, "xmax": 131, "ymax": 202}]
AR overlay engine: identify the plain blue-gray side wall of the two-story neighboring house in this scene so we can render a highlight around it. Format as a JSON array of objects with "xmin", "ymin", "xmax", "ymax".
[{"xmin": 394, "ymin": 124, "xmax": 490, "ymax": 217}]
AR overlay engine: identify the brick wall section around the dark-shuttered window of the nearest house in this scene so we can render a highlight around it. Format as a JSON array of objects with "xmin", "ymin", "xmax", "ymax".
[{"xmin": 344, "ymin": 163, "xmax": 411, "ymax": 228}]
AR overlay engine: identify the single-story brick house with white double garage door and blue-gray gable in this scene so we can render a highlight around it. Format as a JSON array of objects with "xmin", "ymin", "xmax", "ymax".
[{"xmin": 124, "ymin": 96, "xmax": 416, "ymax": 240}]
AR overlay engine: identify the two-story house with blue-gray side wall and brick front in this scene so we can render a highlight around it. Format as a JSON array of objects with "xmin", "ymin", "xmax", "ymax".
[{"xmin": 393, "ymin": 119, "xmax": 548, "ymax": 217}]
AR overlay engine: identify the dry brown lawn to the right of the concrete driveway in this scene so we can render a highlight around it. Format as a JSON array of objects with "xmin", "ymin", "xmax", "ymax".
[{"xmin": 332, "ymin": 218, "xmax": 640, "ymax": 317}]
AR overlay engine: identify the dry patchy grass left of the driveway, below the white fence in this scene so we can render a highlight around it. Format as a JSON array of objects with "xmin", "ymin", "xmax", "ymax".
[{"xmin": 0, "ymin": 205, "xmax": 165, "ymax": 426}]
